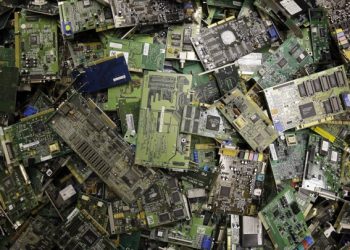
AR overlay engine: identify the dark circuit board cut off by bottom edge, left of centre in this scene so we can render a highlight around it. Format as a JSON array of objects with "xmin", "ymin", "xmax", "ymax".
[{"xmin": 53, "ymin": 208, "xmax": 117, "ymax": 250}]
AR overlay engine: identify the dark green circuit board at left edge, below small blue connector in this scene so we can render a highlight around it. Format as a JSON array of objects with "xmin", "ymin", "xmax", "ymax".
[{"xmin": 0, "ymin": 109, "xmax": 71, "ymax": 167}]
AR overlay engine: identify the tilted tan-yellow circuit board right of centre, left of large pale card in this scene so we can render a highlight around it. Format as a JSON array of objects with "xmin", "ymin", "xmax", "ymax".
[{"xmin": 217, "ymin": 89, "xmax": 278, "ymax": 152}]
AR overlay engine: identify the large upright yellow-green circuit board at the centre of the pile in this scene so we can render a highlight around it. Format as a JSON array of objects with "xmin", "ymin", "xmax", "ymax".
[{"xmin": 135, "ymin": 72, "xmax": 192, "ymax": 169}]
